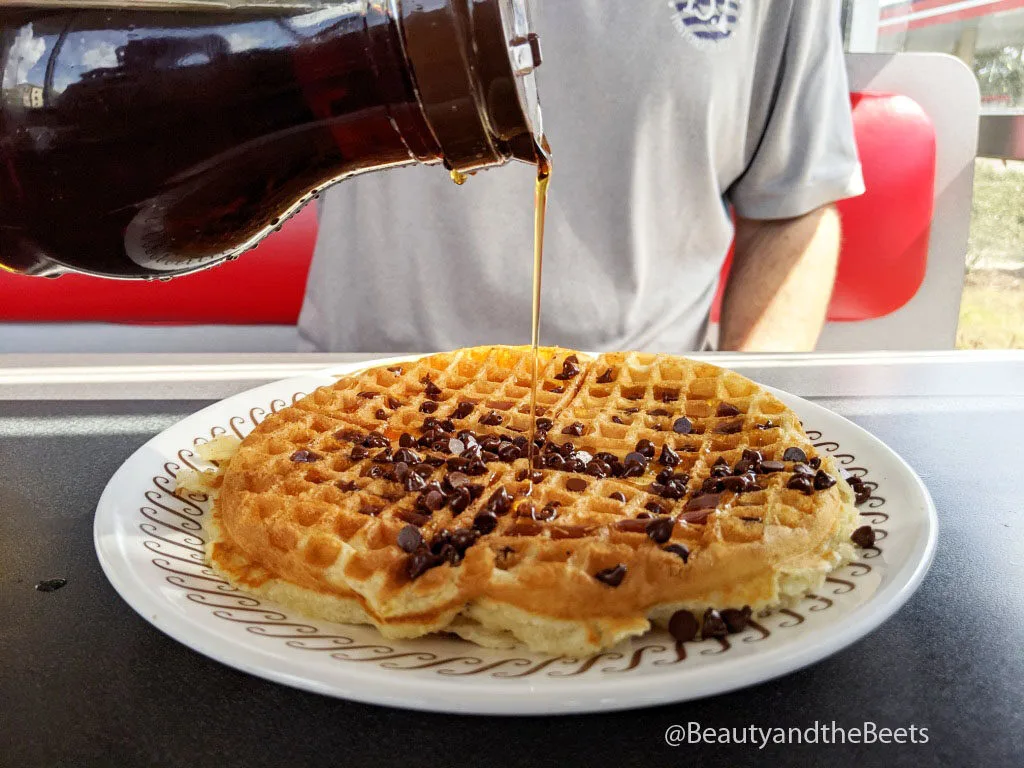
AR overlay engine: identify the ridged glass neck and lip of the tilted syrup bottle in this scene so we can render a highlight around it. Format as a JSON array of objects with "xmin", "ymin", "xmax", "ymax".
[{"xmin": 397, "ymin": 0, "xmax": 542, "ymax": 171}]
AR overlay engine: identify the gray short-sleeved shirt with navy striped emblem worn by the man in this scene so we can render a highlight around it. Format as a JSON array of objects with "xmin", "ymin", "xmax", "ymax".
[{"xmin": 299, "ymin": 0, "xmax": 863, "ymax": 352}]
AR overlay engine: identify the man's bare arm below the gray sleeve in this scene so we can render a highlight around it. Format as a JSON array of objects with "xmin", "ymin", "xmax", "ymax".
[{"xmin": 719, "ymin": 205, "xmax": 840, "ymax": 352}]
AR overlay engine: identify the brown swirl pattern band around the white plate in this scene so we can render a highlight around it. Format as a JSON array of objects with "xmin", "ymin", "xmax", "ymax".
[{"xmin": 138, "ymin": 392, "xmax": 889, "ymax": 680}]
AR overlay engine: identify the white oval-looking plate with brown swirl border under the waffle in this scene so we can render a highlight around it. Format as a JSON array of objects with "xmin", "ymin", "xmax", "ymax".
[{"xmin": 94, "ymin": 364, "xmax": 937, "ymax": 715}]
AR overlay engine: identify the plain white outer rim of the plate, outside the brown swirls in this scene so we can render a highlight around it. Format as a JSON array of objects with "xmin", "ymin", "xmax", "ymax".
[{"xmin": 93, "ymin": 354, "xmax": 938, "ymax": 716}]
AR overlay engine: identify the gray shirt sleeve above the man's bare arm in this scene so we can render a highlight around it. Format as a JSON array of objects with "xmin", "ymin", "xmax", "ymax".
[{"xmin": 727, "ymin": 0, "xmax": 864, "ymax": 219}]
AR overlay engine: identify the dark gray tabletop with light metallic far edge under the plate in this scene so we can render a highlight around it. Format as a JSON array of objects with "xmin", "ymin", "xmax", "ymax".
[{"xmin": 0, "ymin": 353, "xmax": 1024, "ymax": 768}]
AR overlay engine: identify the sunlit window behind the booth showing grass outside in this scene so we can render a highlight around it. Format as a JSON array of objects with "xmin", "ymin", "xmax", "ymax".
[{"xmin": 842, "ymin": 0, "xmax": 1024, "ymax": 348}]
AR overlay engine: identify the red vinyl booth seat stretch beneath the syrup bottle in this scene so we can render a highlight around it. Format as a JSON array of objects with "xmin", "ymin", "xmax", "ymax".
[{"xmin": 0, "ymin": 205, "xmax": 316, "ymax": 326}]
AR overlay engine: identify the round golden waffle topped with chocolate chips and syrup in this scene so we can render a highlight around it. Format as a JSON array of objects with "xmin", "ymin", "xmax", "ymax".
[{"xmin": 199, "ymin": 347, "xmax": 856, "ymax": 656}]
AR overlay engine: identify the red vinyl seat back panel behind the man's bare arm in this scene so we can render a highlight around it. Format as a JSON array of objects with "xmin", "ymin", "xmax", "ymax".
[{"xmin": 712, "ymin": 93, "xmax": 935, "ymax": 322}]
